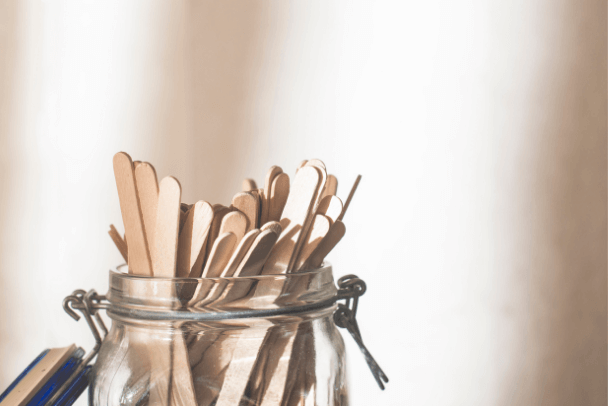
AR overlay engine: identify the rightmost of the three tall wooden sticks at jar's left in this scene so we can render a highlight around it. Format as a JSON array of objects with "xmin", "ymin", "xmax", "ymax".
[{"xmin": 151, "ymin": 176, "xmax": 182, "ymax": 278}]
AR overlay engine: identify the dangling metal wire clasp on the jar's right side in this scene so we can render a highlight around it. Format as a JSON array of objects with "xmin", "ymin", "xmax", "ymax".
[{"xmin": 334, "ymin": 275, "xmax": 388, "ymax": 390}]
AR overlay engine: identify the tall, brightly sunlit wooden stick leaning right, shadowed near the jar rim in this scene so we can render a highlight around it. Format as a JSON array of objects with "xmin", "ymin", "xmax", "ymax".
[{"xmin": 262, "ymin": 166, "xmax": 321, "ymax": 274}]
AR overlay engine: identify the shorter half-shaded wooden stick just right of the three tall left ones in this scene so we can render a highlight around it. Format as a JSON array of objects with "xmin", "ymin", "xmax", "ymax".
[{"xmin": 176, "ymin": 200, "xmax": 213, "ymax": 277}]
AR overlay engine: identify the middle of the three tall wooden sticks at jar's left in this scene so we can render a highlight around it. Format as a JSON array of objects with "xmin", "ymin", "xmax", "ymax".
[{"xmin": 135, "ymin": 162, "xmax": 158, "ymax": 251}]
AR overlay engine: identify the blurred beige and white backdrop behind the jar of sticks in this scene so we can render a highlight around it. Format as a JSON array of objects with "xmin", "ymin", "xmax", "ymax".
[{"xmin": 0, "ymin": 0, "xmax": 607, "ymax": 405}]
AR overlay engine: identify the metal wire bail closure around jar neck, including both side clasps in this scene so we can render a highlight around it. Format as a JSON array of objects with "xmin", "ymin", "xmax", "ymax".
[{"xmin": 58, "ymin": 275, "xmax": 388, "ymax": 394}]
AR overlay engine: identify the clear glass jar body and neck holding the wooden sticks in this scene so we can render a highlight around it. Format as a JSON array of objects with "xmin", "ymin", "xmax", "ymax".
[{"xmin": 89, "ymin": 266, "xmax": 348, "ymax": 406}]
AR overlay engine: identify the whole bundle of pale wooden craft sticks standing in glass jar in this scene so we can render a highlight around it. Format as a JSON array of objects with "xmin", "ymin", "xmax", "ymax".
[{"xmin": 109, "ymin": 152, "xmax": 361, "ymax": 405}]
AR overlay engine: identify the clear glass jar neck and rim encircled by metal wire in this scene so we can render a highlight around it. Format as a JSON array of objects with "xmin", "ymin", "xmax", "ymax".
[{"xmin": 107, "ymin": 266, "xmax": 337, "ymax": 325}]
